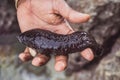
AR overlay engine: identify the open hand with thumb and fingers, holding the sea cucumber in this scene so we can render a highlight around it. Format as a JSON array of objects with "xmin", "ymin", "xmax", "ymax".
[{"xmin": 17, "ymin": 0, "xmax": 94, "ymax": 71}]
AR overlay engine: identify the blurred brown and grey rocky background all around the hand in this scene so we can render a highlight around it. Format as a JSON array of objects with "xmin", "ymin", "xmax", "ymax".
[{"xmin": 0, "ymin": 0, "xmax": 120, "ymax": 80}]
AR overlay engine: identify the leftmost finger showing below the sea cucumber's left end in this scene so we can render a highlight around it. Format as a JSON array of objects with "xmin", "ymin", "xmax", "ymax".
[{"xmin": 19, "ymin": 48, "xmax": 33, "ymax": 61}]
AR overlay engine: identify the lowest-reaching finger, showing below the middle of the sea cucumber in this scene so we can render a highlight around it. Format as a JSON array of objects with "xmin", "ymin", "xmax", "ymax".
[{"xmin": 55, "ymin": 55, "xmax": 68, "ymax": 72}]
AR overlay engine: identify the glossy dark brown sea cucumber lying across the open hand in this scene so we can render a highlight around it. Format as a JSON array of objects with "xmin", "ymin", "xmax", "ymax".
[{"xmin": 18, "ymin": 29, "xmax": 102, "ymax": 55}]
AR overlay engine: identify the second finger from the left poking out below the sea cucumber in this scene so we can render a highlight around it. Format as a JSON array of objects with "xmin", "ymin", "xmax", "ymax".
[{"xmin": 32, "ymin": 53, "xmax": 50, "ymax": 66}]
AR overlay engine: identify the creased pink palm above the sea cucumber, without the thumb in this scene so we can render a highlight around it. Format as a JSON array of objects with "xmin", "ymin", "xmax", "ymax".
[{"xmin": 18, "ymin": 0, "xmax": 73, "ymax": 34}]
